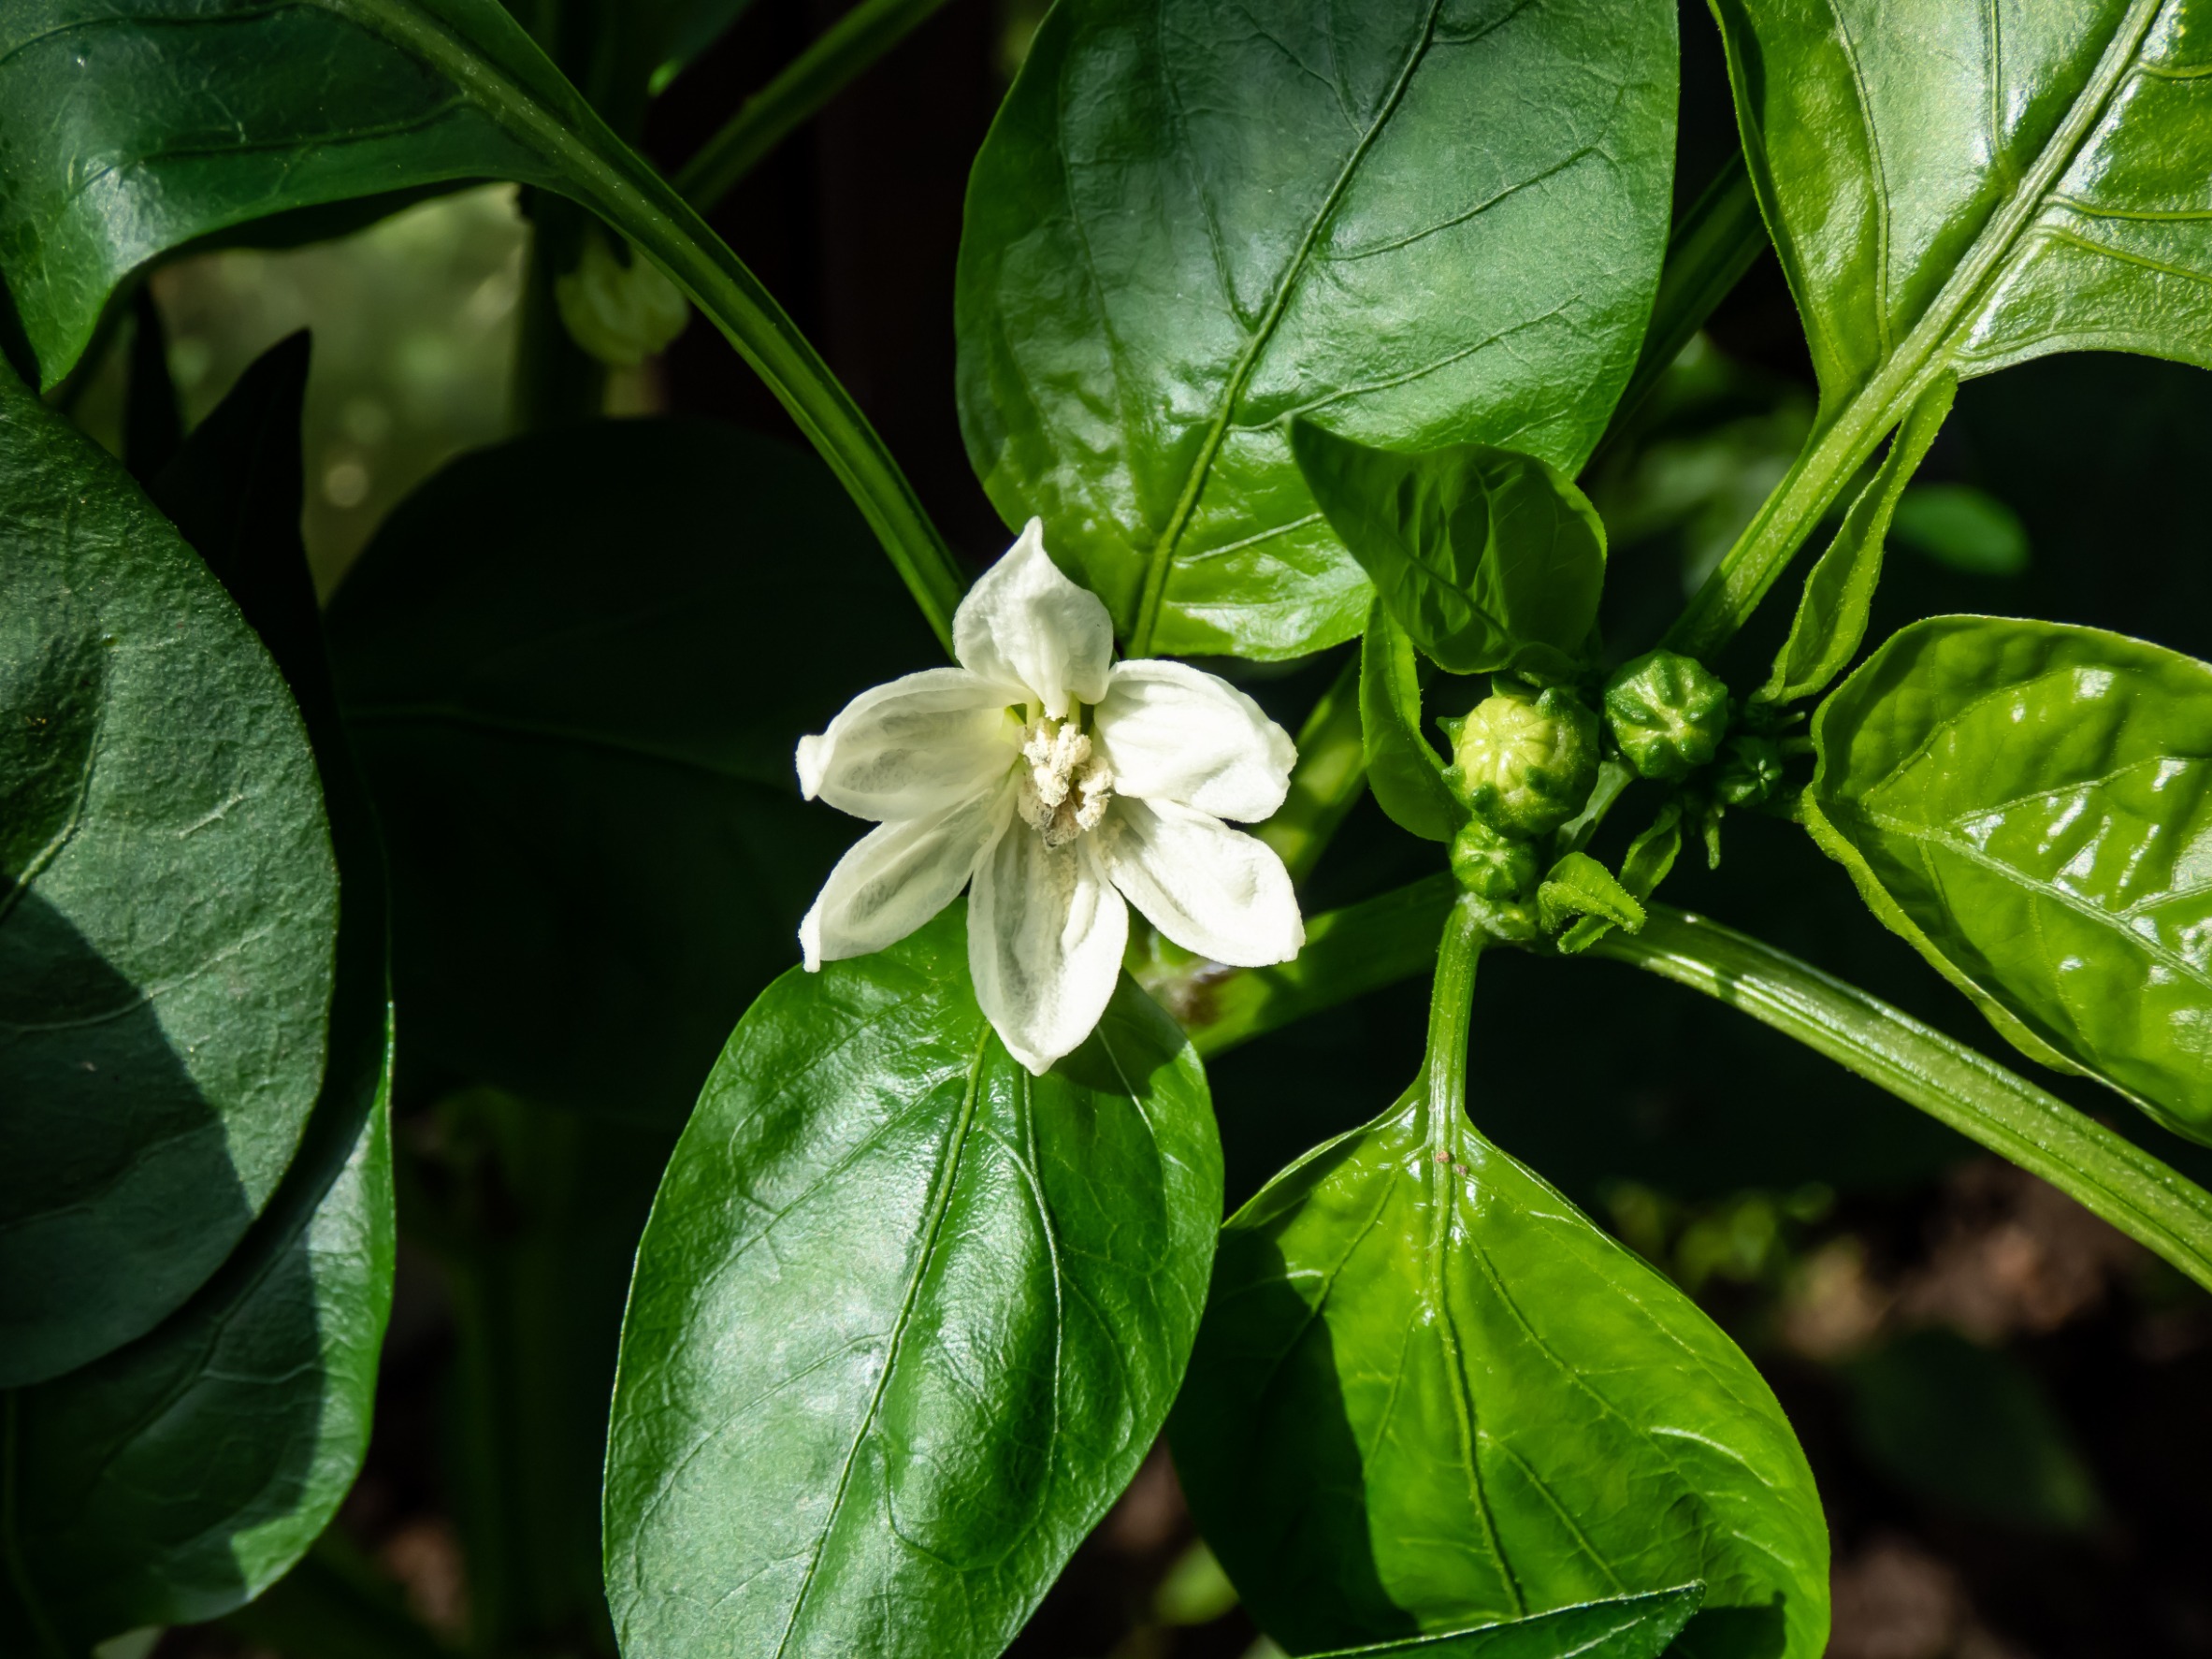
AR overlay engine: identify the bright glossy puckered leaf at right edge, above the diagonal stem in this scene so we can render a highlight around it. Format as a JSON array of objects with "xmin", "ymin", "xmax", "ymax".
[{"xmin": 1802, "ymin": 617, "xmax": 2212, "ymax": 1144}]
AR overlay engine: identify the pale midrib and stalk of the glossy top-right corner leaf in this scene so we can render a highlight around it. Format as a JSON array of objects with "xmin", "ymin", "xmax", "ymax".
[{"xmin": 1663, "ymin": 0, "xmax": 2163, "ymax": 661}]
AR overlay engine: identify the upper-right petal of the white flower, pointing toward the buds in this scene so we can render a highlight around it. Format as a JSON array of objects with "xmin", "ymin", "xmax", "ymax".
[{"xmin": 1097, "ymin": 659, "xmax": 1298, "ymax": 823}]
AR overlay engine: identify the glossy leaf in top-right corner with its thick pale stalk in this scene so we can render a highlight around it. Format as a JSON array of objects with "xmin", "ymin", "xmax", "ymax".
[{"xmin": 1668, "ymin": 0, "xmax": 2212, "ymax": 657}]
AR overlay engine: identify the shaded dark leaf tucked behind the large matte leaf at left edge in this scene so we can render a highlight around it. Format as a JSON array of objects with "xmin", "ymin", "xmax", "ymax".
[{"xmin": 0, "ymin": 337, "xmax": 394, "ymax": 1652}]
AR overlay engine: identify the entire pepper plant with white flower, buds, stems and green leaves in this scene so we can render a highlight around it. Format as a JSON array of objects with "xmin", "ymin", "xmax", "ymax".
[{"xmin": 0, "ymin": 0, "xmax": 2212, "ymax": 1659}]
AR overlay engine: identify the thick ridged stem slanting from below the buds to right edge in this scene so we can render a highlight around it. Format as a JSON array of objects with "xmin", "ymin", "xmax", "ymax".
[{"xmin": 1590, "ymin": 904, "xmax": 2212, "ymax": 1290}]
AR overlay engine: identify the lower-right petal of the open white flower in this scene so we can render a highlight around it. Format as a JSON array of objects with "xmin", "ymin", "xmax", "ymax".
[{"xmin": 1099, "ymin": 797, "xmax": 1305, "ymax": 967}]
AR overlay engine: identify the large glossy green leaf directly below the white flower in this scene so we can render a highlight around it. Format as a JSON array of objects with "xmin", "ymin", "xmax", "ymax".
[{"xmin": 606, "ymin": 904, "xmax": 1221, "ymax": 1659}]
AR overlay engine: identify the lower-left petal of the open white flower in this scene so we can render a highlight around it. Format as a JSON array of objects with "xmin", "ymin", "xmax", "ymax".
[{"xmin": 799, "ymin": 783, "xmax": 1013, "ymax": 974}]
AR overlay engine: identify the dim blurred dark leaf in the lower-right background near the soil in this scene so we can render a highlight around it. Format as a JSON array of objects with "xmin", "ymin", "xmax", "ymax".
[{"xmin": 1844, "ymin": 1330, "xmax": 2102, "ymax": 1533}]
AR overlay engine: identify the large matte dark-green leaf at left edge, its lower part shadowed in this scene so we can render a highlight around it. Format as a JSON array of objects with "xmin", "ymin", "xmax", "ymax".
[{"xmin": 0, "ymin": 368, "xmax": 339, "ymax": 1387}]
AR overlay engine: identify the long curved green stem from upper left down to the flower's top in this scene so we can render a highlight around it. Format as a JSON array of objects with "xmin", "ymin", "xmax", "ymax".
[{"xmin": 338, "ymin": 0, "xmax": 967, "ymax": 653}]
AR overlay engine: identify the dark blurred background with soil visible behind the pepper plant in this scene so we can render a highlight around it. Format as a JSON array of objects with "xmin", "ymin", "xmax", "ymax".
[{"xmin": 68, "ymin": 0, "xmax": 2212, "ymax": 1659}]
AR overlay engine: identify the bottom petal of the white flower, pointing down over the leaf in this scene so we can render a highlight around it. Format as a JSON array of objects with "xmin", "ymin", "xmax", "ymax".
[{"xmin": 969, "ymin": 823, "xmax": 1128, "ymax": 1077}]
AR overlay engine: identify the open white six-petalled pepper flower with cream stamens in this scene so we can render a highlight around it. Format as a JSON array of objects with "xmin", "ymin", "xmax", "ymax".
[{"xmin": 799, "ymin": 520, "xmax": 1305, "ymax": 1075}]
